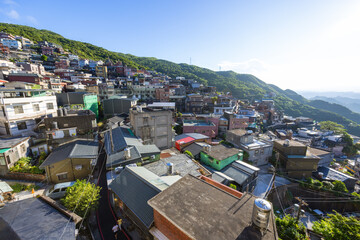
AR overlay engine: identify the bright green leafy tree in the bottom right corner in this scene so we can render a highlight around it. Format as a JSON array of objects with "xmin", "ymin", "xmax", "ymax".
[{"xmin": 313, "ymin": 211, "xmax": 360, "ymax": 240}]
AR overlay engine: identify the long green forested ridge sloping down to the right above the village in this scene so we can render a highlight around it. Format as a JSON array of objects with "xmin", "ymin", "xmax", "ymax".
[{"xmin": 0, "ymin": 23, "xmax": 360, "ymax": 135}]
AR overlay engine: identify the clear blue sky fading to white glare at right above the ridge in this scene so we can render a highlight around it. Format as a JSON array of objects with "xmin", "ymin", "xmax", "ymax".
[{"xmin": 0, "ymin": 0, "xmax": 360, "ymax": 91}]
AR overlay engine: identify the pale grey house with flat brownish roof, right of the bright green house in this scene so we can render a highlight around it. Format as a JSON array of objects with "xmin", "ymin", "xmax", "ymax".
[{"xmin": 226, "ymin": 129, "xmax": 273, "ymax": 166}]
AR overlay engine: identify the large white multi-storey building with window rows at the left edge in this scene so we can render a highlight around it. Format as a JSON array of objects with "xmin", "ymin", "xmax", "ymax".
[{"xmin": 0, "ymin": 89, "xmax": 57, "ymax": 136}]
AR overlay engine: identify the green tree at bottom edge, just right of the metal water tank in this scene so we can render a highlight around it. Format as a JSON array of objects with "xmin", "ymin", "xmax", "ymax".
[{"xmin": 276, "ymin": 215, "xmax": 307, "ymax": 240}]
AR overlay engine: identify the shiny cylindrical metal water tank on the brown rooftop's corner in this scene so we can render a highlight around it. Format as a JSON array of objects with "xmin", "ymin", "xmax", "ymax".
[{"xmin": 252, "ymin": 198, "xmax": 271, "ymax": 232}]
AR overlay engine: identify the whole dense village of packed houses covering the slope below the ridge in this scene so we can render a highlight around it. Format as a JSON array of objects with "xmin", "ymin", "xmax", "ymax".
[{"xmin": 0, "ymin": 32, "xmax": 360, "ymax": 239}]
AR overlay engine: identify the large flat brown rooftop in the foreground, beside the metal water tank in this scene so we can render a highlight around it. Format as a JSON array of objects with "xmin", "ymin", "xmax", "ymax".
[{"xmin": 148, "ymin": 175, "xmax": 277, "ymax": 240}]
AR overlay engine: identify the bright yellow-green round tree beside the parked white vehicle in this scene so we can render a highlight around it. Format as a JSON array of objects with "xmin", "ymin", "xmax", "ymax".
[{"xmin": 61, "ymin": 179, "xmax": 101, "ymax": 217}]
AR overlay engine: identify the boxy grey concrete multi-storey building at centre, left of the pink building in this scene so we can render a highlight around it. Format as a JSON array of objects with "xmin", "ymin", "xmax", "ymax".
[{"xmin": 130, "ymin": 107, "xmax": 175, "ymax": 149}]
